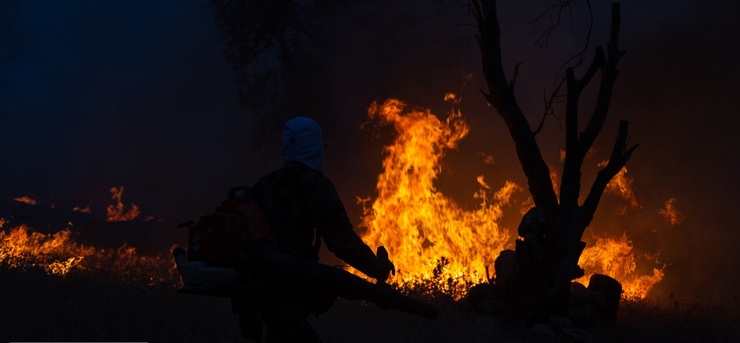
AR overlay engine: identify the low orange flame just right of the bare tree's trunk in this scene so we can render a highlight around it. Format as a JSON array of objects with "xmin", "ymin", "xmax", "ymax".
[{"xmin": 576, "ymin": 233, "xmax": 665, "ymax": 299}]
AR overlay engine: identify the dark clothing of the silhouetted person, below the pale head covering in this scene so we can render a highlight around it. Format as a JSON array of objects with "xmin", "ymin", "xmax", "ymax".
[{"xmin": 242, "ymin": 162, "xmax": 388, "ymax": 342}]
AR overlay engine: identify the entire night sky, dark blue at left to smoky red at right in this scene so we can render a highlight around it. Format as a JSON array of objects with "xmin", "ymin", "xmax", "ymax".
[{"xmin": 0, "ymin": 0, "xmax": 740, "ymax": 295}]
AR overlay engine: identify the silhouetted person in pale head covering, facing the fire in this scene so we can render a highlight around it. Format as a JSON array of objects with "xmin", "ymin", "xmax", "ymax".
[{"xmin": 240, "ymin": 117, "xmax": 395, "ymax": 342}]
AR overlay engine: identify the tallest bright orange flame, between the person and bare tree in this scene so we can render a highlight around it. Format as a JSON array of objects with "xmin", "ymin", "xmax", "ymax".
[{"xmin": 360, "ymin": 99, "xmax": 519, "ymax": 298}]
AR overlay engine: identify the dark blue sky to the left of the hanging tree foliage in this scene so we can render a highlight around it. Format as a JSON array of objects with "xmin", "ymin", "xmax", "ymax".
[{"xmin": 0, "ymin": 1, "xmax": 246, "ymax": 215}]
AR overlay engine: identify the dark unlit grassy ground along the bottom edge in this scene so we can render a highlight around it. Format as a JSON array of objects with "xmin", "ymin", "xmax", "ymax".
[{"xmin": 0, "ymin": 267, "xmax": 740, "ymax": 342}]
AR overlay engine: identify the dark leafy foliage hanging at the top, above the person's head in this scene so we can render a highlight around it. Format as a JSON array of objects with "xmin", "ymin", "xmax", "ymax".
[{"xmin": 210, "ymin": 0, "xmax": 352, "ymax": 127}]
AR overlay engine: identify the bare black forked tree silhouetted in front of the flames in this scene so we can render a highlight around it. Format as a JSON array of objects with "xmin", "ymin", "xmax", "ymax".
[{"xmin": 471, "ymin": 0, "xmax": 637, "ymax": 322}]
